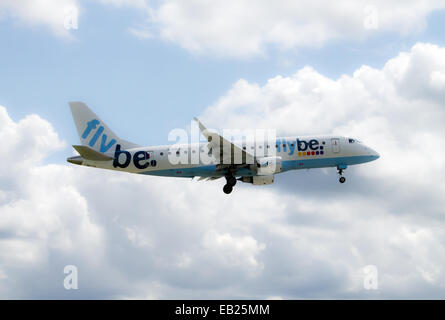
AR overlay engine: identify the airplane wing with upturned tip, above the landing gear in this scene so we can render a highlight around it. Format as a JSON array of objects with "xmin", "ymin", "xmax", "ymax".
[{"xmin": 194, "ymin": 118, "xmax": 255, "ymax": 167}]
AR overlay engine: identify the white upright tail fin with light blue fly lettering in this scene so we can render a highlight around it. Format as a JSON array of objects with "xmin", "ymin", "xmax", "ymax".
[{"xmin": 69, "ymin": 102, "xmax": 139, "ymax": 153}]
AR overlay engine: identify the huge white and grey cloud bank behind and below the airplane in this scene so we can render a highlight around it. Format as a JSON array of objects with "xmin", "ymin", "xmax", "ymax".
[{"xmin": 0, "ymin": 44, "xmax": 445, "ymax": 299}]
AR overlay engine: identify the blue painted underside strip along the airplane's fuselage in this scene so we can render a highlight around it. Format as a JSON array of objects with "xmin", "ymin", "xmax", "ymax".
[{"xmin": 141, "ymin": 156, "xmax": 378, "ymax": 178}]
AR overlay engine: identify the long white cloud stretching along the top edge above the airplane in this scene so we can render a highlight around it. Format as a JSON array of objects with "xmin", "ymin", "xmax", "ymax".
[{"xmin": 134, "ymin": 0, "xmax": 444, "ymax": 57}]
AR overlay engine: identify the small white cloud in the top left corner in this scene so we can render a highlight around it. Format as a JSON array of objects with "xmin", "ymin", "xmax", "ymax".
[{"xmin": 0, "ymin": 0, "xmax": 79, "ymax": 37}]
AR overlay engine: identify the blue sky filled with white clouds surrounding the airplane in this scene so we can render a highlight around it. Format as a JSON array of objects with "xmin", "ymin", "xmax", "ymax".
[{"xmin": 0, "ymin": 0, "xmax": 445, "ymax": 299}]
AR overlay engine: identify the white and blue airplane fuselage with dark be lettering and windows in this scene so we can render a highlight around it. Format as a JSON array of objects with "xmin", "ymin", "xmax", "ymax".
[{"xmin": 70, "ymin": 136, "xmax": 379, "ymax": 178}]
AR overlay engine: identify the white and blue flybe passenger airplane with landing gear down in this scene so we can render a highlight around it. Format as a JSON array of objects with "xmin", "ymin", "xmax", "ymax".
[{"xmin": 67, "ymin": 102, "xmax": 380, "ymax": 194}]
